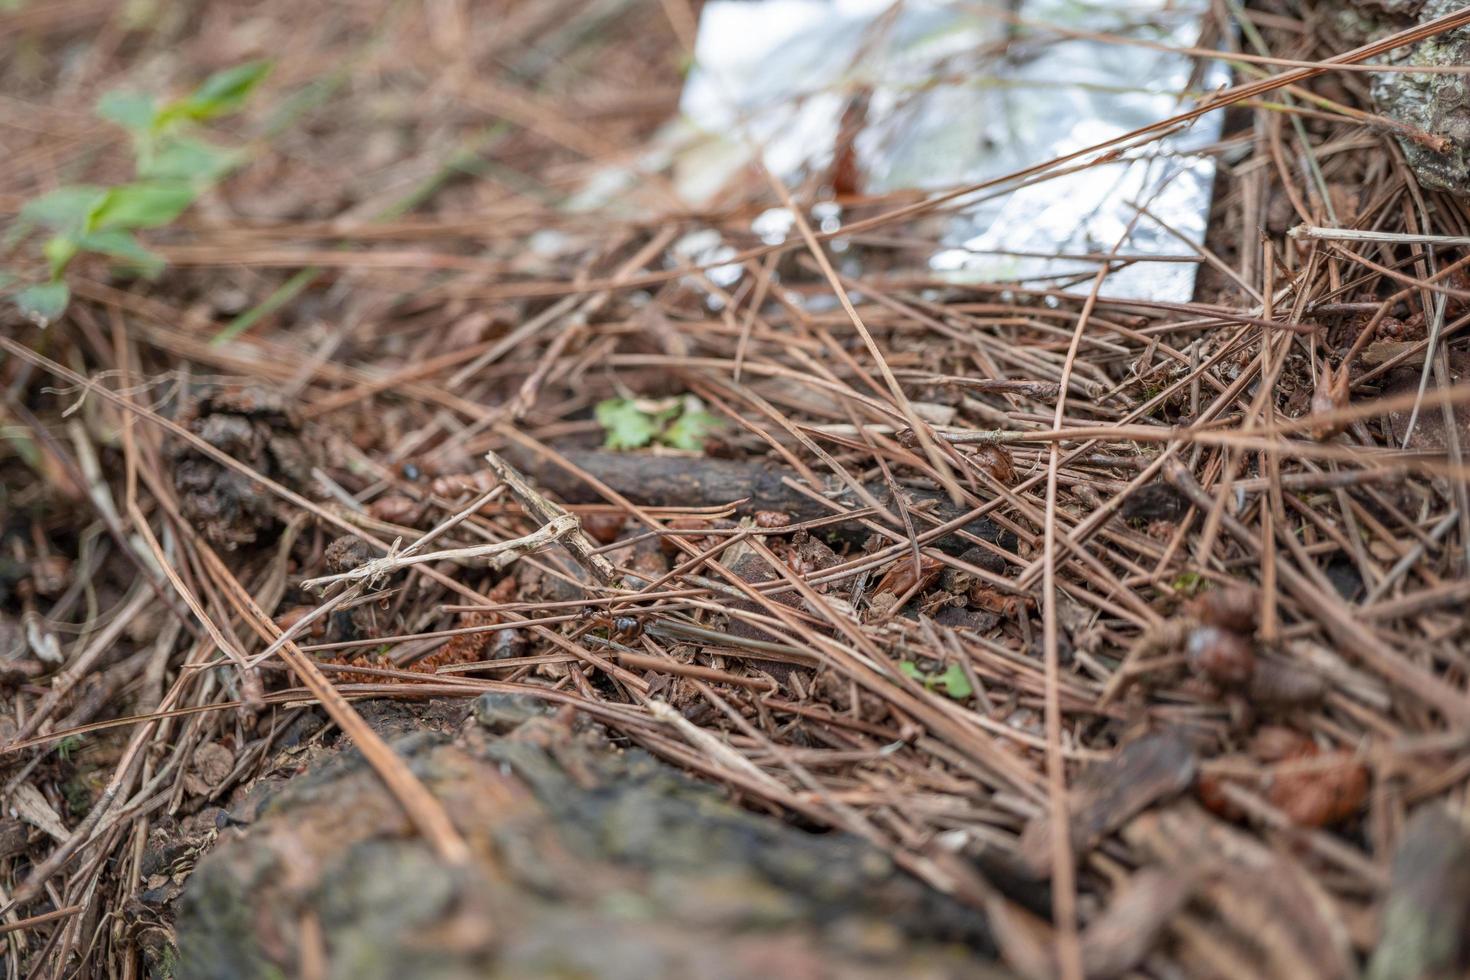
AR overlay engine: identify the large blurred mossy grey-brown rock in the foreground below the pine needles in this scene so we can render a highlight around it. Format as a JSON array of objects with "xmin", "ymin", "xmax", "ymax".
[{"xmin": 176, "ymin": 717, "xmax": 1005, "ymax": 980}]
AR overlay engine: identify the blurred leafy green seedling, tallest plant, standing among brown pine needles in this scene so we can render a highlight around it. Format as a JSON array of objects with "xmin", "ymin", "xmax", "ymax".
[{"xmin": 0, "ymin": 62, "xmax": 270, "ymax": 326}]
